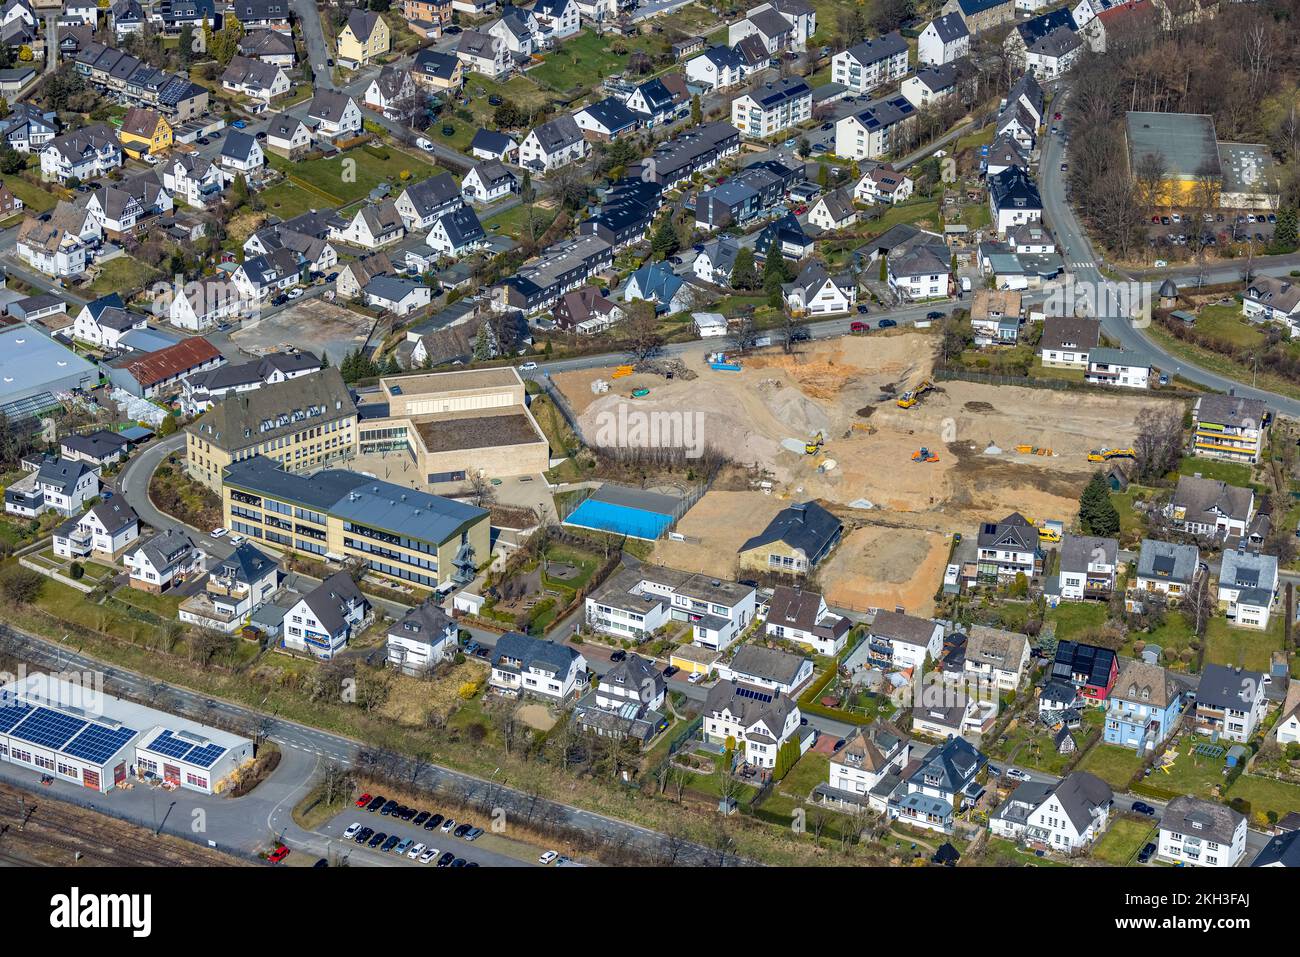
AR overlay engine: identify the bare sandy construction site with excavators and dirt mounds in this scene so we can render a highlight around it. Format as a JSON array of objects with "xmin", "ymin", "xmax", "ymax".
[{"xmin": 554, "ymin": 332, "xmax": 1171, "ymax": 614}]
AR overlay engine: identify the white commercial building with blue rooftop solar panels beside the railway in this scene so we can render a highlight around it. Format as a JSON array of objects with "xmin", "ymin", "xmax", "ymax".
[{"xmin": 0, "ymin": 674, "xmax": 254, "ymax": 793}]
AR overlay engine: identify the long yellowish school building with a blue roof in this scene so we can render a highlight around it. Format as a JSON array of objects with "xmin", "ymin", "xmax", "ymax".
[{"xmin": 221, "ymin": 452, "xmax": 491, "ymax": 588}]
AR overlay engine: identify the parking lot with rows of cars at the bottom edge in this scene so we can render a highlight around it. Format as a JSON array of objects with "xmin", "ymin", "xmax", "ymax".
[{"xmin": 319, "ymin": 794, "xmax": 569, "ymax": 867}]
